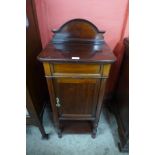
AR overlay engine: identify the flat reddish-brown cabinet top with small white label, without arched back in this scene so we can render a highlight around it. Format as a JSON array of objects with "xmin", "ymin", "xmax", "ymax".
[{"xmin": 38, "ymin": 42, "xmax": 115, "ymax": 63}]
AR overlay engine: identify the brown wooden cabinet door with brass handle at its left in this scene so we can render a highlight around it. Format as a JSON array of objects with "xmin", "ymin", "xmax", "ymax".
[{"xmin": 54, "ymin": 78, "xmax": 100, "ymax": 117}]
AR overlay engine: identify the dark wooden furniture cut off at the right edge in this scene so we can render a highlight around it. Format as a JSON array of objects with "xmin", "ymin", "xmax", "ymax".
[{"xmin": 113, "ymin": 38, "xmax": 129, "ymax": 152}]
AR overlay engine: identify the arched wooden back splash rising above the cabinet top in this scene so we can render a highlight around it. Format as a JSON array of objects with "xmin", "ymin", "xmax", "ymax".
[{"xmin": 52, "ymin": 19, "xmax": 105, "ymax": 44}]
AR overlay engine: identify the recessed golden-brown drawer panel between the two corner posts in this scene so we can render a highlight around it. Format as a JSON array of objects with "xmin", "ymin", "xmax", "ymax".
[{"xmin": 53, "ymin": 64, "xmax": 100, "ymax": 73}]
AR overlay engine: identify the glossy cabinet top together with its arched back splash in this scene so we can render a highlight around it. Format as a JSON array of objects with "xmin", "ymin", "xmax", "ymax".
[{"xmin": 37, "ymin": 19, "xmax": 116, "ymax": 63}]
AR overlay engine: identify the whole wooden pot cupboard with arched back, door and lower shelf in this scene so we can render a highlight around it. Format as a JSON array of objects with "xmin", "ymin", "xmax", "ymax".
[{"xmin": 38, "ymin": 19, "xmax": 115, "ymax": 138}]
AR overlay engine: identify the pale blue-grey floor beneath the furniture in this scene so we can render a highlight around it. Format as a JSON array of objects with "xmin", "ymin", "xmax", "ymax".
[{"xmin": 26, "ymin": 107, "xmax": 128, "ymax": 155}]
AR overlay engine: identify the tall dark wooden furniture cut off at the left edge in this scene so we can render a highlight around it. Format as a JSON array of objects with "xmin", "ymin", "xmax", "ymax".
[{"xmin": 26, "ymin": 0, "xmax": 48, "ymax": 137}]
